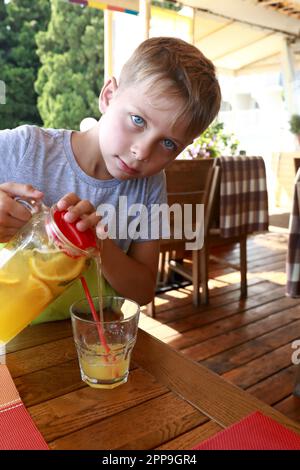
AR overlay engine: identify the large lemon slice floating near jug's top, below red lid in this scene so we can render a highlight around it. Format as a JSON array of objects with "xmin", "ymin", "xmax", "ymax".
[{"xmin": 29, "ymin": 250, "xmax": 85, "ymax": 282}]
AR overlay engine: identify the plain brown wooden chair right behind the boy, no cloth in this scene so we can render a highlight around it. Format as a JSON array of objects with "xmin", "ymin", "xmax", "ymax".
[{"xmin": 147, "ymin": 159, "xmax": 219, "ymax": 317}]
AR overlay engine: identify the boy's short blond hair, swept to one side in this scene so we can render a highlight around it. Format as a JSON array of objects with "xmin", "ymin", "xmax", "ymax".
[{"xmin": 119, "ymin": 37, "xmax": 221, "ymax": 138}]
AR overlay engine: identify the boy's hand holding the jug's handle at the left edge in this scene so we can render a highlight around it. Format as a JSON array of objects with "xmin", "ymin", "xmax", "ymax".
[{"xmin": 0, "ymin": 183, "xmax": 43, "ymax": 243}]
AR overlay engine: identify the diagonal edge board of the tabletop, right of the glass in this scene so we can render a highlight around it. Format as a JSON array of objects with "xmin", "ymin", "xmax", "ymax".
[{"xmin": 133, "ymin": 330, "xmax": 300, "ymax": 433}]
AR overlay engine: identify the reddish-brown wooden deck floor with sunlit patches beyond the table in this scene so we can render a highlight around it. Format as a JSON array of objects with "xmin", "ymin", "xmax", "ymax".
[{"xmin": 141, "ymin": 233, "xmax": 300, "ymax": 422}]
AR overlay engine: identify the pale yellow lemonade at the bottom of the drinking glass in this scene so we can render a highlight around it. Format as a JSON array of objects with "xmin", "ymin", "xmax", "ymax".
[{"xmin": 78, "ymin": 344, "xmax": 130, "ymax": 388}]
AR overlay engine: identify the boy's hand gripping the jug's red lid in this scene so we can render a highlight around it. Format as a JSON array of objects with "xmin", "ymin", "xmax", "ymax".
[{"xmin": 56, "ymin": 193, "xmax": 101, "ymax": 232}]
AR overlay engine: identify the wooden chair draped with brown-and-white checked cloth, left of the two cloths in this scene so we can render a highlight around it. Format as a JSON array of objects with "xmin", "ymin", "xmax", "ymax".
[{"xmin": 206, "ymin": 156, "xmax": 268, "ymax": 298}]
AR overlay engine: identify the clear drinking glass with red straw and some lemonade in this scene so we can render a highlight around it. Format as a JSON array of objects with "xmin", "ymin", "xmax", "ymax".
[{"xmin": 70, "ymin": 296, "xmax": 140, "ymax": 389}]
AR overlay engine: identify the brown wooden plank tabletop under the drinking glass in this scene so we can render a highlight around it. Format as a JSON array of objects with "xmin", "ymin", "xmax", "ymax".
[{"xmin": 7, "ymin": 321, "xmax": 300, "ymax": 450}]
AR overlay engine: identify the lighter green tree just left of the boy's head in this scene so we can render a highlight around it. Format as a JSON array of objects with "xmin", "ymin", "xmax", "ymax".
[{"xmin": 36, "ymin": 0, "xmax": 104, "ymax": 129}]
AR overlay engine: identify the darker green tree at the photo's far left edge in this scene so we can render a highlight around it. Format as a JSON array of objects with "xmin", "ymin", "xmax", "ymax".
[{"xmin": 0, "ymin": 0, "xmax": 50, "ymax": 129}]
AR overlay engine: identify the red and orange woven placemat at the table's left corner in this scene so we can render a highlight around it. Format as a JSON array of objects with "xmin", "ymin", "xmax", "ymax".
[{"xmin": 0, "ymin": 364, "xmax": 49, "ymax": 450}]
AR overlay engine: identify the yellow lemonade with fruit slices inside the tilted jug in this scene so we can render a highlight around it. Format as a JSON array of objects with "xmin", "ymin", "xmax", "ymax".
[{"xmin": 0, "ymin": 248, "xmax": 86, "ymax": 344}]
